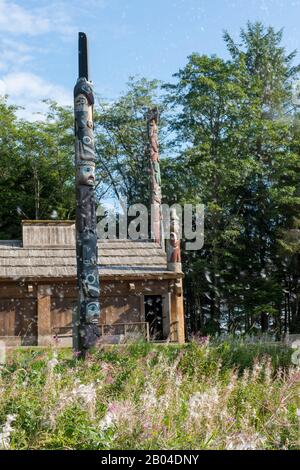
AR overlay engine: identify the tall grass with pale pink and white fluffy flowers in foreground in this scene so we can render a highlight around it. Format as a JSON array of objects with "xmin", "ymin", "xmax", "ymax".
[{"xmin": 0, "ymin": 341, "xmax": 300, "ymax": 449}]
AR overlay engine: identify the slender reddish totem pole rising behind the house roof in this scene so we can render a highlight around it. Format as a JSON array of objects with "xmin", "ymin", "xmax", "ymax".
[{"xmin": 147, "ymin": 108, "xmax": 162, "ymax": 245}]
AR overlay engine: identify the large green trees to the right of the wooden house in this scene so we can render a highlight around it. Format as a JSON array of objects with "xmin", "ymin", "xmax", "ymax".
[{"xmin": 166, "ymin": 23, "xmax": 300, "ymax": 333}]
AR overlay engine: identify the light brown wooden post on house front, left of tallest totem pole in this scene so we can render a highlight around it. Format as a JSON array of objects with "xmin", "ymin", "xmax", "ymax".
[{"xmin": 37, "ymin": 286, "xmax": 53, "ymax": 346}]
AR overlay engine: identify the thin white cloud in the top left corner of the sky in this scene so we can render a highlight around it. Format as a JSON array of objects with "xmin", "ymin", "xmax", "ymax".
[{"xmin": 0, "ymin": 0, "xmax": 74, "ymax": 36}]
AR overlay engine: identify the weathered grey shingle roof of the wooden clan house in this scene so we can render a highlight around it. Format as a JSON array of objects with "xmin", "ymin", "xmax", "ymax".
[{"xmin": 0, "ymin": 221, "xmax": 178, "ymax": 280}]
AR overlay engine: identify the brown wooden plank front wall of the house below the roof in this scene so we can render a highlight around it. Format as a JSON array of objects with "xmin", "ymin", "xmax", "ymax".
[{"xmin": 0, "ymin": 280, "xmax": 169, "ymax": 336}]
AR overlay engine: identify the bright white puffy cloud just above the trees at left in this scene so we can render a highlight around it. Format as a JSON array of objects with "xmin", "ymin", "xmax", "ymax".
[{"xmin": 0, "ymin": 72, "xmax": 72, "ymax": 121}]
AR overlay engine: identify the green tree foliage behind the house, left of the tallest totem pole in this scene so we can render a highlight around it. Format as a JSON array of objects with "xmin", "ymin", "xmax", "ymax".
[{"xmin": 0, "ymin": 99, "xmax": 75, "ymax": 238}]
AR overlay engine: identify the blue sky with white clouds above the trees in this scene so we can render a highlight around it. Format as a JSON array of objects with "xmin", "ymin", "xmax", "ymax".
[{"xmin": 0, "ymin": 0, "xmax": 300, "ymax": 118}]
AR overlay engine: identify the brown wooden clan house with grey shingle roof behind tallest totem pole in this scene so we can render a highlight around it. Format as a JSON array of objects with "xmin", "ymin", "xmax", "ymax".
[{"xmin": 0, "ymin": 220, "xmax": 184, "ymax": 345}]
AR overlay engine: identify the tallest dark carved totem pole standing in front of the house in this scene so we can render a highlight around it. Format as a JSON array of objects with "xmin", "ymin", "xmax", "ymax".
[{"xmin": 73, "ymin": 33, "xmax": 100, "ymax": 356}]
